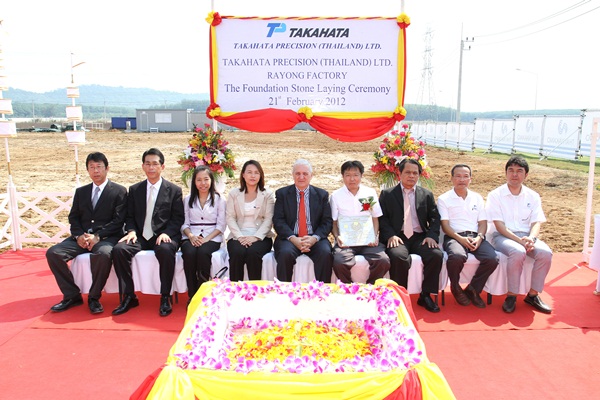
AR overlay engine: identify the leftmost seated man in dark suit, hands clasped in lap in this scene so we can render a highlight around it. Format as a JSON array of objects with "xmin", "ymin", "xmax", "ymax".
[{"xmin": 46, "ymin": 153, "xmax": 127, "ymax": 314}]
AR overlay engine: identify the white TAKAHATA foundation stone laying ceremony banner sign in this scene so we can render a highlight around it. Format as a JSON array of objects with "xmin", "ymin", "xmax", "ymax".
[{"xmin": 213, "ymin": 18, "xmax": 404, "ymax": 112}]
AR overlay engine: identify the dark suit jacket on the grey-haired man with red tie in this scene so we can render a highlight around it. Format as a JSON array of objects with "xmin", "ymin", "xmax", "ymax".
[{"xmin": 273, "ymin": 185, "xmax": 333, "ymax": 239}]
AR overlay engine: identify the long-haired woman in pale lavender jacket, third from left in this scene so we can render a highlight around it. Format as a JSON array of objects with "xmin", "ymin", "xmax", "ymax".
[{"xmin": 181, "ymin": 165, "xmax": 225, "ymax": 299}]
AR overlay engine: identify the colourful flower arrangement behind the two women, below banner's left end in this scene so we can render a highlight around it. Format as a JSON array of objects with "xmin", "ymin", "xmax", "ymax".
[{"xmin": 177, "ymin": 124, "xmax": 236, "ymax": 185}]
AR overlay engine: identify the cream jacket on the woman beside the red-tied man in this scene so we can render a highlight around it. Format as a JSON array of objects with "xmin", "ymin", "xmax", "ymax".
[{"xmin": 225, "ymin": 188, "xmax": 275, "ymax": 240}]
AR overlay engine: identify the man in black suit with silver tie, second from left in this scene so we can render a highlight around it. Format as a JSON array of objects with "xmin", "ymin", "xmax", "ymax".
[{"xmin": 112, "ymin": 148, "xmax": 184, "ymax": 317}]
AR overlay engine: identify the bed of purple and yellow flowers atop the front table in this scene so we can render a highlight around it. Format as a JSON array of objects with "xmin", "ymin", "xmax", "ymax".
[{"xmin": 175, "ymin": 280, "xmax": 423, "ymax": 373}]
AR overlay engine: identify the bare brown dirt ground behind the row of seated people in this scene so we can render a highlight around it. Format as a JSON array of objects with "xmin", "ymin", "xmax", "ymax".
[{"xmin": 0, "ymin": 131, "xmax": 600, "ymax": 252}]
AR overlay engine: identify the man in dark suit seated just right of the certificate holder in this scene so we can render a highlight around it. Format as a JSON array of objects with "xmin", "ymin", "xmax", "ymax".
[{"xmin": 379, "ymin": 158, "xmax": 444, "ymax": 312}]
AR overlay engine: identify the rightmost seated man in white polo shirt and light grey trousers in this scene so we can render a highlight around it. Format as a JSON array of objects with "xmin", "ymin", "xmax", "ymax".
[{"xmin": 486, "ymin": 156, "xmax": 552, "ymax": 314}]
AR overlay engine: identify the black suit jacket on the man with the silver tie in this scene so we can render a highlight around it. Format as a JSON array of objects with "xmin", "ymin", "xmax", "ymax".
[{"xmin": 125, "ymin": 179, "xmax": 184, "ymax": 242}]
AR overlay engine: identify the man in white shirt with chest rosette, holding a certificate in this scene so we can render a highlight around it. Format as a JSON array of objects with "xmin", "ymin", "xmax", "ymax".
[{"xmin": 329, "ymin": 161, "xmax": 390, "ymax": 284}]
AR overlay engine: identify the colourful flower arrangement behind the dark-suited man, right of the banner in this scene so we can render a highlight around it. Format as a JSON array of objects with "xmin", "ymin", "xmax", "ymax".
[{"xmin": 371, "ymin": 124, "xmax": 433, "ymax": 188}]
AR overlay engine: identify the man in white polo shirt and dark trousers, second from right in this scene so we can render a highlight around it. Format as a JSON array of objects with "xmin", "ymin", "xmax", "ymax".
[{"xmin": 438, "ymin": 164, "xmax": 498, "ymax": 308}]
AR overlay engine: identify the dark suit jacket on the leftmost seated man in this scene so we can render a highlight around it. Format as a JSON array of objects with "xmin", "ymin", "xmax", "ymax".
[{"xmin": 69, "ymin": 180, "xmax": 127, "ymax": 239}]
